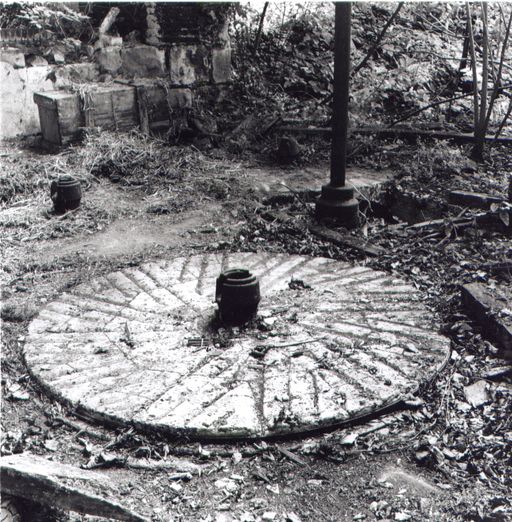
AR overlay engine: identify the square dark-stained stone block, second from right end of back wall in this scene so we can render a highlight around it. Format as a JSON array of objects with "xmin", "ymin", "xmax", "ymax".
[{"xmin": 169, "ymin": 44, "xmax": 210, "ymax": 85}]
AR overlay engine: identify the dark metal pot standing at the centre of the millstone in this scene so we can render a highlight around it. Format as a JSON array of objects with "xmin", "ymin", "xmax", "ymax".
[{"xmin": 215, "ymin": 268, "xmax": 261, "ymax": 325}]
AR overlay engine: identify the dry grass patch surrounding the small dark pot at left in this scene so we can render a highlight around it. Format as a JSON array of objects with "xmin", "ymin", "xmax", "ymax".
[{"xmin": 0, "ymin": 130, "xmax": 260, "ymax": 242}]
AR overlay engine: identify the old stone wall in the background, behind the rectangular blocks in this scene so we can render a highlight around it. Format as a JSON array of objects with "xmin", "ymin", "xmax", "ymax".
[{"xmin": 0, "ymin": 2, "xmax": 231, "ymax": 139}]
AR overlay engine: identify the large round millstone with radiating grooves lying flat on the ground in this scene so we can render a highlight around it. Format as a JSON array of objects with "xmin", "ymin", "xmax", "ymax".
[{"xmin": 25, "ymin": 253, "xmax": 449, "ymax": 440}]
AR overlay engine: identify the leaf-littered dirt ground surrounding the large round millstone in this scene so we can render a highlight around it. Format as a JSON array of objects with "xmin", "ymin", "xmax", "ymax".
[{"xmin": 0, "ymin": 135, "xmax": 512, "ymax": 522}]
